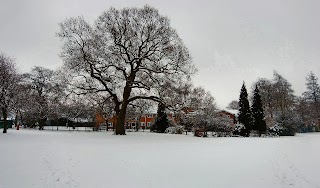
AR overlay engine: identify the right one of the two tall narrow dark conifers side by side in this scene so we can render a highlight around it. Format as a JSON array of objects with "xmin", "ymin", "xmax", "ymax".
[{"xmin": 251, "ymin": 85, "xmax": 267, "ymax": 136}]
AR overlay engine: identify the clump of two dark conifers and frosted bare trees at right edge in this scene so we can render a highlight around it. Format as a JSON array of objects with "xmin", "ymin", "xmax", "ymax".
[{"xmin": 228, "ymin": 71, "xmax": 320, "ymax": 135}]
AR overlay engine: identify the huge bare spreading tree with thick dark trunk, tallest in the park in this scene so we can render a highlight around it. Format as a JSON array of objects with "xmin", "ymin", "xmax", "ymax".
[{"xmin": 58, "ymin": 6, "xmax": 195, "ymax": 135}]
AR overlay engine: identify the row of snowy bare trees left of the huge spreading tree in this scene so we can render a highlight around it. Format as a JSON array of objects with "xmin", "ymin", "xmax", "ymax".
[{"xmin": 0, "ymin": 53, "xmax": 98, "ymax": 133}]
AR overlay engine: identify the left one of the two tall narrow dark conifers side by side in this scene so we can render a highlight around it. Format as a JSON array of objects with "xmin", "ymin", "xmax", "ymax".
[{"xmin": 238, "ymin": 83, "xmax": 253, "ymax": 137}]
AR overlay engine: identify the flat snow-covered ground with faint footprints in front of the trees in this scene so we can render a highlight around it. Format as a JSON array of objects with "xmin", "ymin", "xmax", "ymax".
[{"xmin": 0, "ymin": 129, "xmax": 320, "ymax": 188}]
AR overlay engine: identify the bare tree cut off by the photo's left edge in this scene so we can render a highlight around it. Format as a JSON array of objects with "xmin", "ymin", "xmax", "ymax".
[{"xmin": 0, "ymin": 53, "xmax": 20, "ymax": 133}]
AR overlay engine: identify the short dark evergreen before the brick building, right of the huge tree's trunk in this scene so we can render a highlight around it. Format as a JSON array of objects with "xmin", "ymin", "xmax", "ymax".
[{"xmin": 153, "ymin": 103, "xmax": 169, "ymax": 133}]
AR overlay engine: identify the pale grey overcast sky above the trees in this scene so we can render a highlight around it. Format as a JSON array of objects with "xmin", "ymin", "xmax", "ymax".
[{"xmin": 0, "ymin": 0, "xmax": 320, "ymax": 108}]
